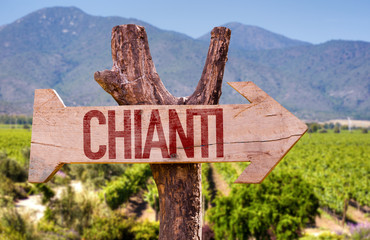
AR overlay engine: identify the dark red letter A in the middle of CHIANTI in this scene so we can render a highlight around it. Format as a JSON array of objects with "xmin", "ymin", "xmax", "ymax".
[{"xmin": 143, "ymin": 109, "xmax": 170, "ymax": 158}]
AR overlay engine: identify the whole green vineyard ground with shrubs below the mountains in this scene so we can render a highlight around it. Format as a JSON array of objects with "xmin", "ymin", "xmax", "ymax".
[{"xmin": 0, "ymin": 125, "xmax": 370, "ymax": 239}]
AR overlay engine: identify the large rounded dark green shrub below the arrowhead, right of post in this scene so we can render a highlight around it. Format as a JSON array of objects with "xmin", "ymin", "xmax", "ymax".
[{"xmin": 207, "ymin": 172, "xmax": 319, "ymax": 240}]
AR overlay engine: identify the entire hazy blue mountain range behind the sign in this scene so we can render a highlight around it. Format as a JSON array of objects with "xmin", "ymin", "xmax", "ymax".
[{"xmin": 0, "ymin": 7, "xmax": 370, "ymax": 120}]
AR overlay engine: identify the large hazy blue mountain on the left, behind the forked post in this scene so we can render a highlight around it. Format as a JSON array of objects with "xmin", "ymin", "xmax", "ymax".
[{"xmin": 0, "ymin": 7, "xmax": 207, "ymax": 113}]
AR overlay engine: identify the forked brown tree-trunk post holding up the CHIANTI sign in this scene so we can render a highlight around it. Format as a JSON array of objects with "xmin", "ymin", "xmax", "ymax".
[{"xmin": 94, "ymin": 24, "xmax": 231, "ymax": 240}]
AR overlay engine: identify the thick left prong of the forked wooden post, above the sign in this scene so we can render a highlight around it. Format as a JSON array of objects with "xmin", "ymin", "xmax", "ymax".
[{"xmin": 94, "ymin": 24, "xmax": 179, "ymax": 105}]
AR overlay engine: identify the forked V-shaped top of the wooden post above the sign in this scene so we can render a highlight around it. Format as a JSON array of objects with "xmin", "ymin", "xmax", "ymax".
[{"xmin": 94, "ymin": 24, "xmax": 231, "ymax": 105}]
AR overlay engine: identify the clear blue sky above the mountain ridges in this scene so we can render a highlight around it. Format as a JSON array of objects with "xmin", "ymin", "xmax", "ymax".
[{"xmin": 0, "ymin": 0, "xmax": 370, "ymax": 44}]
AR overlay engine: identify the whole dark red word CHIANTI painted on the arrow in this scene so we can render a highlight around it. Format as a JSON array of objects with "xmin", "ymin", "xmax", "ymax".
[{"xmin": 83, "ymin": 108, "xmax": 224, "ymax": 160}]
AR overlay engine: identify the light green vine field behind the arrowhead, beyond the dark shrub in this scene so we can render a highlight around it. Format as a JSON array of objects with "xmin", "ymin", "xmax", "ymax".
[{"xmin": 213, "ymin": 131, "xmax": 370, "ymax": 218}]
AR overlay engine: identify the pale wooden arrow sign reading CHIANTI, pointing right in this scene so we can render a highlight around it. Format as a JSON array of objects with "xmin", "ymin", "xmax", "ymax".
[{"xmin": 29, "ymin": 82, "xmax": 307, "ymax": 183}]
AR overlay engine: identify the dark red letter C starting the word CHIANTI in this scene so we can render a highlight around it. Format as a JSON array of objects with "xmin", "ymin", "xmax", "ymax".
[{"xmin": 83, "ymin": 110, "xmax": 107, "ymax": 160}]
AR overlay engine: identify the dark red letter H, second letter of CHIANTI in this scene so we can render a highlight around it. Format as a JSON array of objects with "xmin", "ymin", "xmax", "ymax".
[{"xmin": 108, "ymin": 110, "xmax": 131, "ymax": 159}]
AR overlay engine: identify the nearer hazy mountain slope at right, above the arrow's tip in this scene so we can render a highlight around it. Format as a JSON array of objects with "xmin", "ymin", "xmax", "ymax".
[{"xmin": 225, "ymin": 41, "xmax": 370, "ymax": 119}]
